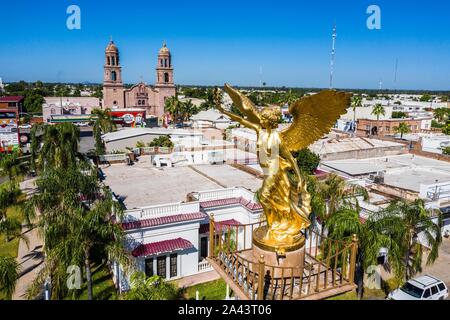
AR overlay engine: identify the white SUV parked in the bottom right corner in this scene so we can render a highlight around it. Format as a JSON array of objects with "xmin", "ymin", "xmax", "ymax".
[{"xmin": 387, "ymin": 275, "xmax": 448, "ymax": 300}]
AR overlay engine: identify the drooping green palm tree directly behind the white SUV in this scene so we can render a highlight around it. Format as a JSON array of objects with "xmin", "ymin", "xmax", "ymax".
[{"xmin": 373, "ymin": 199, "xmax": 442, "ymax": 280}]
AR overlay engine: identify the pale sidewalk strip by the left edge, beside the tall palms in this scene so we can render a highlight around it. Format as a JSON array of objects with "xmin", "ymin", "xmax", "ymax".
[{"xmin": 12, "ymin": 179, "xmax": 44, "ymax": 300}]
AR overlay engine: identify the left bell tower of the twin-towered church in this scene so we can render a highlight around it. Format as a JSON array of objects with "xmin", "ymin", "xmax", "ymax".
[{"xmin": 103, "ymin": 39, "xmax": 125, "ymax": 109}]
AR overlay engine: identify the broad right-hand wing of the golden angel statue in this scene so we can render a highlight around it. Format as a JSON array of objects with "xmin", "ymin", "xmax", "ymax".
[{"xmin": 281, "ymin": 90, "xmax": 351, "ymax": 151}]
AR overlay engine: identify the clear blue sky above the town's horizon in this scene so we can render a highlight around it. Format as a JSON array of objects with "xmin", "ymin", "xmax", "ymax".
[{"xmin": 0, "ymin": 0, "xmax": 450, "ymax": 90}]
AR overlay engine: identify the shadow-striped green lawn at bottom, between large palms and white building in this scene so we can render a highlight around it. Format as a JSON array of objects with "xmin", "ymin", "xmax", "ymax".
[{"xmin": 67, "ymin": 264, "xmax": 118, "ymax": 300}]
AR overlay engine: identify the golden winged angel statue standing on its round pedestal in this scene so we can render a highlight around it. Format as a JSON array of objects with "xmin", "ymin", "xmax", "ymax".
[{"xmin": 216, "ymin": 84, "xmax": 351, "ymax": 252}]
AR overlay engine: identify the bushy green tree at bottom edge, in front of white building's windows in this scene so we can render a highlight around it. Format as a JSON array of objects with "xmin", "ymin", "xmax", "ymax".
[{"xmin": 122, "ymin": 272, "xmax": 182, "ymax": 300}]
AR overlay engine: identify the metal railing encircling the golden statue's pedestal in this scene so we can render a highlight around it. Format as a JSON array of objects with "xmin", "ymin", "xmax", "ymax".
[{"xmin": 208, "ymin": 217, "xmax": 358, "ymax": 300}]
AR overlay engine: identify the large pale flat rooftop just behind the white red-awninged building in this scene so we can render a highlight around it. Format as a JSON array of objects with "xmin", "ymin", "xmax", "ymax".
[{"xmin": 101, "ymin": 156, "xmax": 262, "ymax": 209}]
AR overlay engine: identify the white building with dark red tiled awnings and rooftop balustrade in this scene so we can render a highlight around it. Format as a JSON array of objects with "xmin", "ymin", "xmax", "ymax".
[{"xmin": 113, "ymin": 187, "xmax": 263, "ymax": 290}]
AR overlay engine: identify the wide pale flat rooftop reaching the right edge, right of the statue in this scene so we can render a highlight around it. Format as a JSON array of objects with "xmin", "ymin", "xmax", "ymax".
[{"xmin": 322, "ymin": 154, "xmax": 450, "ymax": 192}]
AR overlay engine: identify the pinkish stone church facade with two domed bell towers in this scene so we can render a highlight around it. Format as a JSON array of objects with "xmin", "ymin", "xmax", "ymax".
[{"xmin": 103, "ymin": 40, "xmax": 176, "ymax": 118}]
